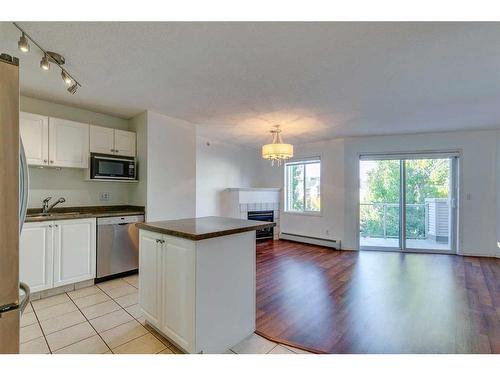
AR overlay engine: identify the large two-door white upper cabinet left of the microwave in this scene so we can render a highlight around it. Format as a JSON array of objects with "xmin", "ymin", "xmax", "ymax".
[{"xmin": 20, "ymin": 112, "xmax": 89, "ymax": 168}]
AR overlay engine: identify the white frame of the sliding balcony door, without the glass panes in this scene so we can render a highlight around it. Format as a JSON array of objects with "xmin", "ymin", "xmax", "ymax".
[{"xmin": 356, "ymin": 150, "xmax": 462, "ymax": 254}]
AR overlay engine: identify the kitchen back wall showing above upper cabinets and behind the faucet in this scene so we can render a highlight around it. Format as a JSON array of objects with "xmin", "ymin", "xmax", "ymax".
[{"xmin": 20, "ymin": 96, "xmax": 132, "ymax": 208}]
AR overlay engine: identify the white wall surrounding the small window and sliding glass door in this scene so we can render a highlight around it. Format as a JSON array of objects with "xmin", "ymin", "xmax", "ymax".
[{"xmin": 264, "ymin": 131, "xmax": 500, "ymax": 256}]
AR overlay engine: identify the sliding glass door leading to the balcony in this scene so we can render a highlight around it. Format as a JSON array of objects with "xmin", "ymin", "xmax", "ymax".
[{"xmin": 359, "ymin": 154, "xmax": 458, "ymax": 253}]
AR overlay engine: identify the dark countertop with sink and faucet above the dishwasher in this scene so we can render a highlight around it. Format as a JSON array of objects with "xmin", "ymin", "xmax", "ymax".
[{"xmin": 25, "ymin": 205, "xmax": 144, "ymax": 223}]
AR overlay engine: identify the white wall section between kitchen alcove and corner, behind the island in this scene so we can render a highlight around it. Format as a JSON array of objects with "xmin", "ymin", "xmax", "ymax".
[{"xmin": 146, "ymin": 111, "xmax": 196, "ymax": 221}]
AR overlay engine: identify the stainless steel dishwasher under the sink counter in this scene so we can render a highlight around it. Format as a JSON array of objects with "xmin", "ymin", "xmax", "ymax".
[{"xmin": 96, "ymin": 215, "xmax": 144, "ymax": 280}]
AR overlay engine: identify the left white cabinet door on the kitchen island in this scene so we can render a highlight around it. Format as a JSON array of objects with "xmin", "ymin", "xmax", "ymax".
[{"xmin": 139, "ymin": 230, "xmax": 162, "ymax": 328}]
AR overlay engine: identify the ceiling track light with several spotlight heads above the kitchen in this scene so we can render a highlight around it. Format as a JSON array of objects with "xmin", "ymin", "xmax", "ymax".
[{"xmin": 13, "ymin": 22, "xmax": 82, "ymax": 95}]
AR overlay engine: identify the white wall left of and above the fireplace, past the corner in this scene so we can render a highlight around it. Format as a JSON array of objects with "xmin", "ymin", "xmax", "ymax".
[{"xmin": 196, "ymin": 137, "xmax": 262, "ymax": 217}]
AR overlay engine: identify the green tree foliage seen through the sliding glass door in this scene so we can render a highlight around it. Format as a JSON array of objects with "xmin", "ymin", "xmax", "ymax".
[{"xmin": 360, "ymin": 159, "xmax": 450, "ymax": 238}]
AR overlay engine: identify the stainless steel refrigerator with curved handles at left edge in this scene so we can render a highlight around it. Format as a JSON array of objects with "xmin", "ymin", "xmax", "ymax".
[{"xmin": 0, "ymin": 54, "xmax": 29, "ymax": 353}]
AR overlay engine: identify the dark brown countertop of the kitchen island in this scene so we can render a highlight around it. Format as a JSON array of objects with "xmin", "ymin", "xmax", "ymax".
[{"xmin": 136, "ymin": 216, "xmax": 276, "ymax": 241}]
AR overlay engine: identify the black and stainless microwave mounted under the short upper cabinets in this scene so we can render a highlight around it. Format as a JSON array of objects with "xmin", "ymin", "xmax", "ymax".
[{"xmin": 90, "ymin": 153, "xmax": 137, "ymax": 180}]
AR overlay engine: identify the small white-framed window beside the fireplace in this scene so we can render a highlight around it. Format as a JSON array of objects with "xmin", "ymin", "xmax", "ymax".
[{"xmin": 285, "ymin": 159, "xmax": 321, "ymax": 213}]
